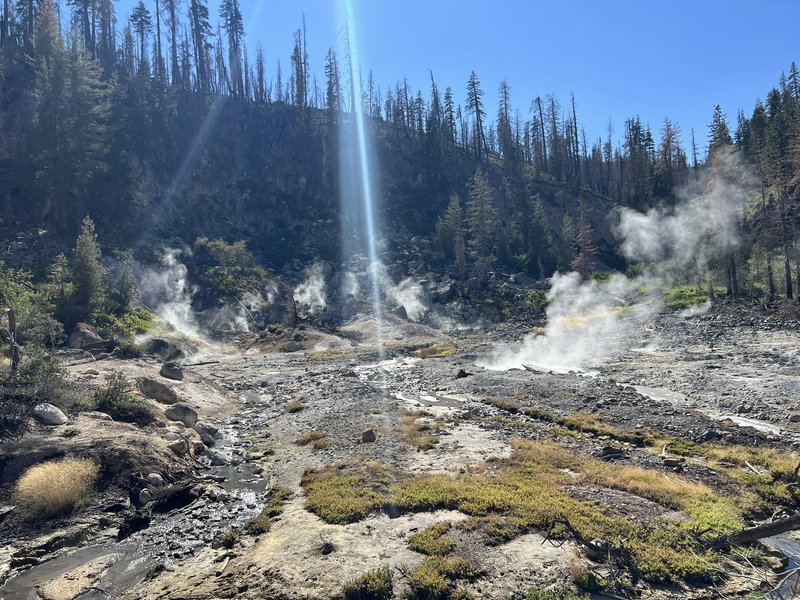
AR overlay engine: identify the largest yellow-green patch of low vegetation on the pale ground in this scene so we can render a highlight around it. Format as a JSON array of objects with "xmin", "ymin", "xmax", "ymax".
[{"xmin": 302, "ymin": 440, "xmax": 754, "ymax": 584}]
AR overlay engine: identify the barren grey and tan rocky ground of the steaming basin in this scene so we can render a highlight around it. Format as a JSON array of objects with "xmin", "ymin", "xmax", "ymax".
[{"xmin": 0, "ymin": 307, "xmax": 800, "ymax": 599}]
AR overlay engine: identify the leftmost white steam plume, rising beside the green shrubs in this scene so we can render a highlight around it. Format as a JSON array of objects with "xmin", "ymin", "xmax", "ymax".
[{"xmin": 137, "ymin": 248, "xmax": 200, "ymax": 337}]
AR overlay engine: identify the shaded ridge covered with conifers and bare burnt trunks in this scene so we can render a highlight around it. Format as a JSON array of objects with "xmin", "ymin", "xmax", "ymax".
[{"xmin": 0, "ymin": 0, "xmax": 800, "ymax": 296}]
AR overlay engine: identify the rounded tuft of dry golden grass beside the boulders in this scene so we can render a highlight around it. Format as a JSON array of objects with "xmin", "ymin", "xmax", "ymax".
[{"xmin": 14, "ymin": 458, "xmax": 100, "ymax": 517}]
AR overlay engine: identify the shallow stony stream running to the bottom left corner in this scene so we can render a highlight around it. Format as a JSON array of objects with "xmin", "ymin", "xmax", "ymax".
[{"xmin": 0, "ymin": 392, "xmax": 281, "ymax": 600}]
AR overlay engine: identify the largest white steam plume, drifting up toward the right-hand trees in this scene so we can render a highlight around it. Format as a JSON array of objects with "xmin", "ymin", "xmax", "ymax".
[{"xmin": 478, "ymin": 152, "xmax": 752, "ymax": 372}]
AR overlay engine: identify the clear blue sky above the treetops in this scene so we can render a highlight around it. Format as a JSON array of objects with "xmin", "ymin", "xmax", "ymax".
[{"xmin": 112, "ymin": 0, "xmax": 800, "ymax": 155}]
